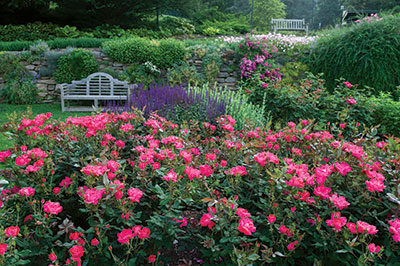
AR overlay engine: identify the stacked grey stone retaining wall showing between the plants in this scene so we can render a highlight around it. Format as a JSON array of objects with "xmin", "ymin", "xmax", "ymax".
[{"xmin": 0, "ymin": 48, "xmax": 237, "ymax": 103}]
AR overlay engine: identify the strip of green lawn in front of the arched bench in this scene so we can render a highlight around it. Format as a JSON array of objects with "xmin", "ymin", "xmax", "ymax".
[{"xmin": 0, "ymin": 104, "xmax": 90, "ymax": 150}]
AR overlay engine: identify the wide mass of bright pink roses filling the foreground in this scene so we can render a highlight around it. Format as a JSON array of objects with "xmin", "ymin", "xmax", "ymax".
[{"xmin": 0, "ymin": 109, "xmax": 400, "ymax": 265}]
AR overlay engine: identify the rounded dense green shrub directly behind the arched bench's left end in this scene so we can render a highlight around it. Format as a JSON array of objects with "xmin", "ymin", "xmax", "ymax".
[{"xmin": 54, "ymin": 49, "xmax": 98, "ymax": 83}]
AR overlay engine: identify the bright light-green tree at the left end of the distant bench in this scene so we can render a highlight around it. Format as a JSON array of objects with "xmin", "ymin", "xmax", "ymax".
[{"xmin": 250, "ymin": 0, "xmax": 285, "ymax": 30}]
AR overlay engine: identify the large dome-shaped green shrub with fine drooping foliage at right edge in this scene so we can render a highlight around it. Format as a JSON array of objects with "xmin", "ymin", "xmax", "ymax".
[{"xmin": 308, "ymin": 15, "xmax": 400, "ymax": 96}]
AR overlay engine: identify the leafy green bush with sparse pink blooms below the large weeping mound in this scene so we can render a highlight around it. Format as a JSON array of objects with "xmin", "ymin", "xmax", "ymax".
[{"xmin": 256, "ymin": 75, "xmax": 400, "ymax": 138}]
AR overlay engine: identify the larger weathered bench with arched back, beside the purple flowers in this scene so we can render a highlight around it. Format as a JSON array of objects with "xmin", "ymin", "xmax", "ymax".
[{"xmin": 60, "ymin": 72, "xmax": 130, "ymax": 112}]
